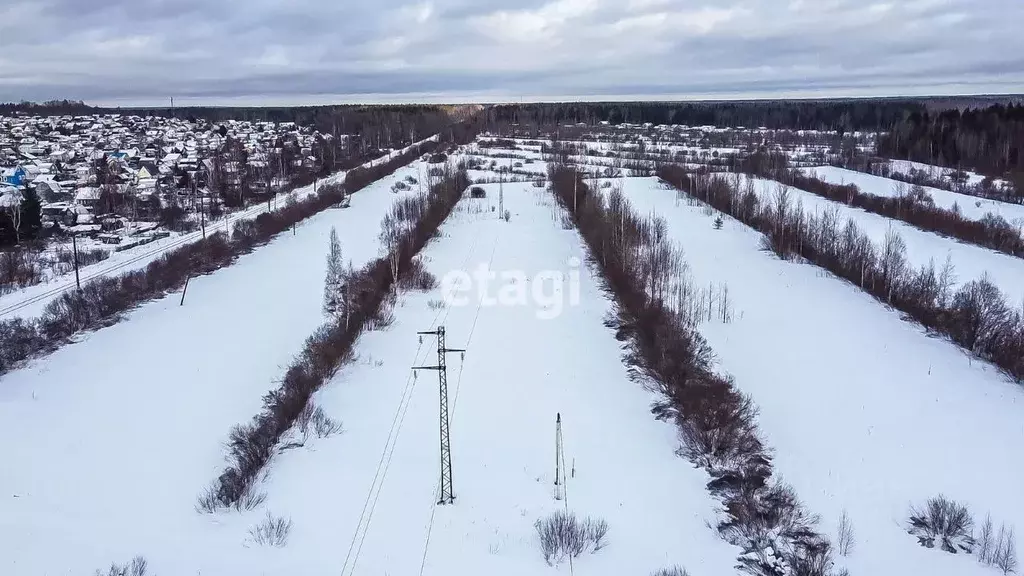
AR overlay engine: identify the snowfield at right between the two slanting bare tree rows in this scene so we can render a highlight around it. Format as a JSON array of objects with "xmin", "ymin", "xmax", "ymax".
[{"xmin": 740, "ymin": 172, "xmax": 1024, "ymax": 305}]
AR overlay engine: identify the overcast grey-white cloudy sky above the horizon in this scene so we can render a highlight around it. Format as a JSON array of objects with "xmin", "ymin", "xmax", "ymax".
[{"xmin": 0, "ymin": 0, "xmax": 1024, "ymax": 106}]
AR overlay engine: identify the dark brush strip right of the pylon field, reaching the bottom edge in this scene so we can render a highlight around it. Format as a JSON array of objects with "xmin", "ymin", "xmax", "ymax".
[{"xmin": 549, "ymin": 165, "xmax": 833, "ymax": 576}]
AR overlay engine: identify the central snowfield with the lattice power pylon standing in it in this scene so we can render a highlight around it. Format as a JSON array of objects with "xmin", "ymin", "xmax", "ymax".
[{"xmin": 250, "ymin": 180, "xmax": 737, "ymax": 576}]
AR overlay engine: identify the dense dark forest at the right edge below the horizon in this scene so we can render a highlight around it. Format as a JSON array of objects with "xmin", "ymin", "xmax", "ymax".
[{"xmin": 879, "ymin": 104, "xmax": 1024, "ymax": 183}]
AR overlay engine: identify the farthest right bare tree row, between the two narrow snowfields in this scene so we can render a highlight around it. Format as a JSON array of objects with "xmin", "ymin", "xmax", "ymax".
[{"xmin": 742, "ymin": 154, "xmax": 1024, "ymax": 257}]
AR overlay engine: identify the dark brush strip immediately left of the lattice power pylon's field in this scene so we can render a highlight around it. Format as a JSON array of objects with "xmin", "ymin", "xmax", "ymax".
[{"xmin": 197, "ymin": 164, "xmax": 470, "ymax": 511}]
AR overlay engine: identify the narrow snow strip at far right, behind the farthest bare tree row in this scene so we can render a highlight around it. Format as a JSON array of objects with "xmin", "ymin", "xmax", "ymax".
[{"xmin": 803, "ymin": 166, "xmax": 1024, "ymax": 227}]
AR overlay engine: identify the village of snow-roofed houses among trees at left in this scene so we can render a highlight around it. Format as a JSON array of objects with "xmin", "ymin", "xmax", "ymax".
[{"xmin": 0, "ymin": 114, "xmax": 344, "ymax": 244}]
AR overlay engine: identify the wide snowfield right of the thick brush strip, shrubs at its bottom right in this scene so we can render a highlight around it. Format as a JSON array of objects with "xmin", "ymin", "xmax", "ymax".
[{"xmin": 625, "ymin": 174, "xmax": 1024, "ymax": 576}]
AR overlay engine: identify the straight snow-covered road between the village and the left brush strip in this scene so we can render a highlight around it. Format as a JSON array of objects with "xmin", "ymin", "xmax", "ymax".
[{"xmin": 0, "ymin": 135, "xmax": 437, "ymax": 319}]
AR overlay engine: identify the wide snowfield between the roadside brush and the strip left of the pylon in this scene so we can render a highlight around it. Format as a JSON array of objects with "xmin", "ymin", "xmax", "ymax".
[{"xmin": 0, "ymin": 163, "xmax": 425, "ymax": 576}]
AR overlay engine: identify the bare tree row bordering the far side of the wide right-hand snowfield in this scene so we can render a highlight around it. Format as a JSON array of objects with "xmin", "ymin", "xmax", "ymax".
[{"xmin": 658, "ymin": 166, "xmax": 1024, "ymax": 382}]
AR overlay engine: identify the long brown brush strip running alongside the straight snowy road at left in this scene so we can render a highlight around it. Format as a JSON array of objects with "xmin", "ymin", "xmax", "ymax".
[{"xmin": 0, "ymin": 141, "xmax": 438, "ymax": 374}]
